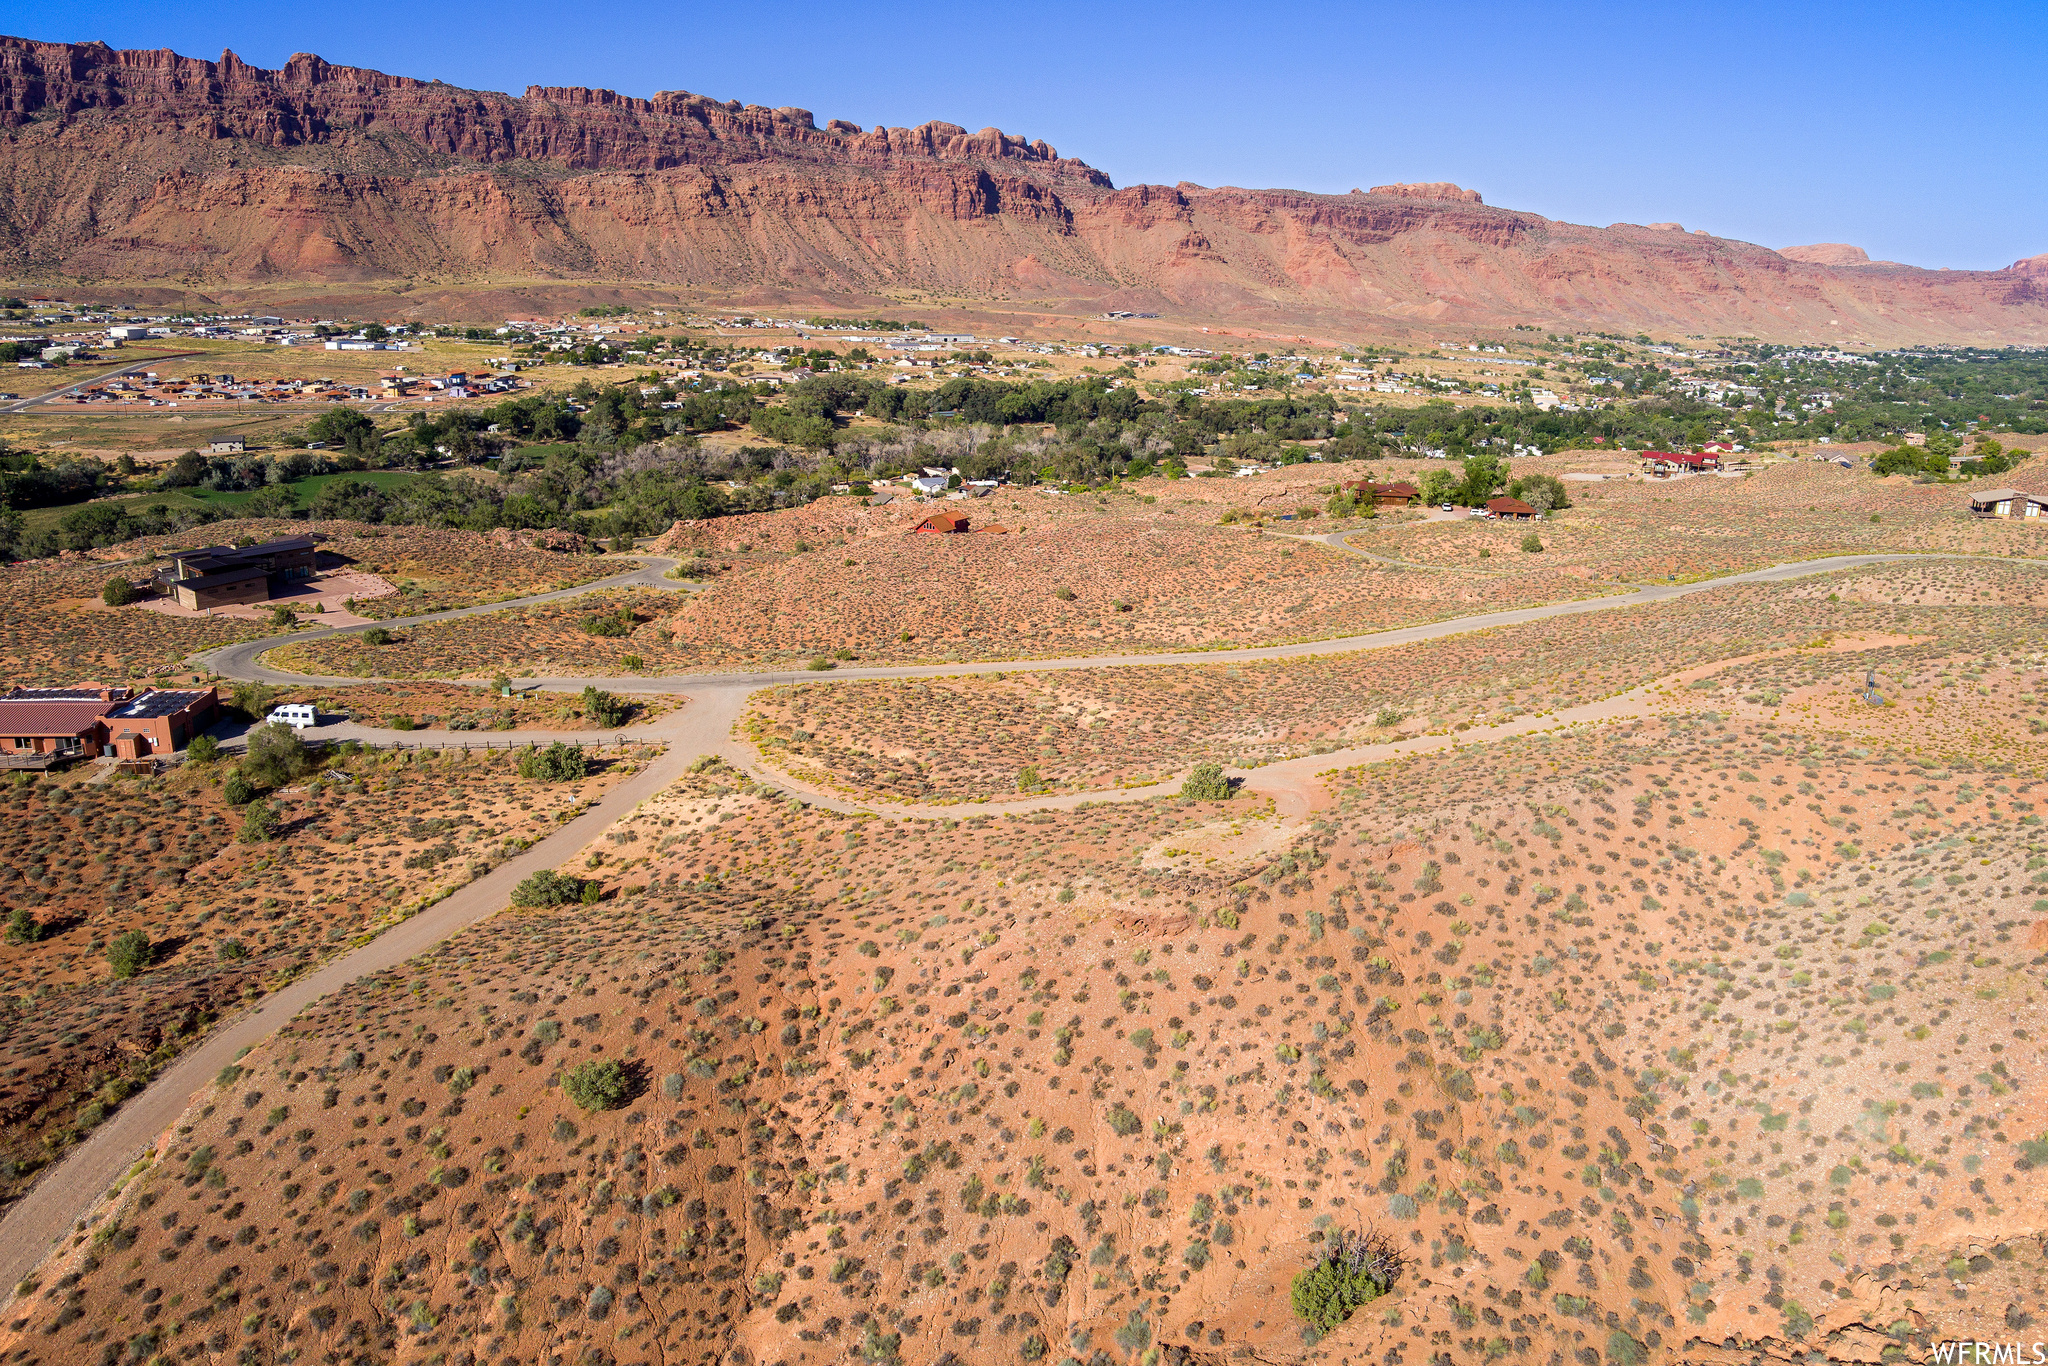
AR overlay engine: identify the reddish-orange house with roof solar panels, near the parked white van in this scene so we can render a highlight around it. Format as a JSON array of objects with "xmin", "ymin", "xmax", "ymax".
[{"xmin": 0, "ymin": 688, "xmax": 219, "ymax": 768}]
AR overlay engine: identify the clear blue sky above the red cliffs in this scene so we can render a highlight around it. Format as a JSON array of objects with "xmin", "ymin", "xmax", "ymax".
[{"xmin": 16, "ymin": 0, "xmax": 2048, "ymax": 268}]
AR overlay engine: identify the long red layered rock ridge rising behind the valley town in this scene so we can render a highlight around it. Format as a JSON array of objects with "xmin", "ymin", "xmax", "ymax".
[{"xmin": 0, "ymin": 39, "xmax": 2048, "ymax": 344}]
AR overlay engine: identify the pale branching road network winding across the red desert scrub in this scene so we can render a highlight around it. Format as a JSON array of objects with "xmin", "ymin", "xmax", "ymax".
[{"xmin": 0, "ymin": 547, "xmax": 1998, "ymax": 1294}]
